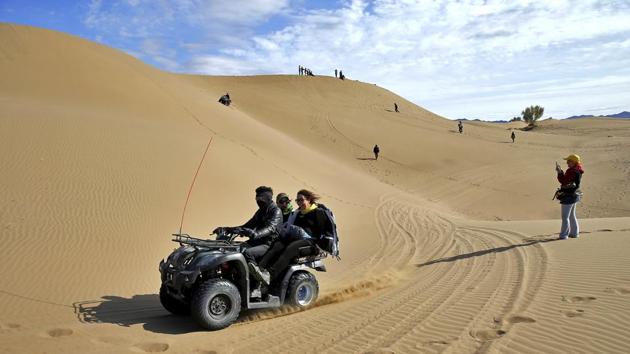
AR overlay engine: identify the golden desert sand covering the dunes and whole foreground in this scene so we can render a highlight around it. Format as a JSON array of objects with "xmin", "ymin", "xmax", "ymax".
[{"xmin": 0, "ymin": 24, "xmax": 630, "ymax": 353}]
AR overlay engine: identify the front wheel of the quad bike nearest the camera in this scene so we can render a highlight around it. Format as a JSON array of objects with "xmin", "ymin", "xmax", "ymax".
[{"xmin": 190, "ymin": 279, "xmax": 241, "ymax": 331}]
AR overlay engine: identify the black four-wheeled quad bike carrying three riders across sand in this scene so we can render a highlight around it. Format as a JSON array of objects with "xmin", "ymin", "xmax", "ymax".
[{"xmin": 160, "ymin": 229, "xmax": 327, "ymax": 330}]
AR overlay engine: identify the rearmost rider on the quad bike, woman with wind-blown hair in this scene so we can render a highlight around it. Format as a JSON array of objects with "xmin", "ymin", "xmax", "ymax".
[{"xmin": 249, "ymin": 189, "xmax": 334, "ymax": 285}]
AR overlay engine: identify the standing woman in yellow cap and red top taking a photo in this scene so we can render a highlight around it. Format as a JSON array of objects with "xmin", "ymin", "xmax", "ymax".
[{"xmin": 556, "ymin": 154, "xmax": 584, "ymax": 240}]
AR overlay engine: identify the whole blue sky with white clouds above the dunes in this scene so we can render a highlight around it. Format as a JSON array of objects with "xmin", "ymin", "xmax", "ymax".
[{"xmin": 0, "ymin": 0, "xmax": 630, "ymax": 120}]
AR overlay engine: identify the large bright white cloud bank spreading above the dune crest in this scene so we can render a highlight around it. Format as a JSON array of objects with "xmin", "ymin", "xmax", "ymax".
[{"xmin": 194, "ymin": 0, "xmax": 630, "ymax": 119}]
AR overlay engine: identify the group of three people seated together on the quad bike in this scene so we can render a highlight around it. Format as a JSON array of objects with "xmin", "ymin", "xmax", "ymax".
[{"xmin": 213, "ymin": 186, "xmax": 336, "ymax": 285}]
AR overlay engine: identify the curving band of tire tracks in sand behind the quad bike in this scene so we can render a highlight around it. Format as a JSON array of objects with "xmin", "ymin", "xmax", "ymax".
[{"xmin": 235, "ymin": 195, "xmax": 546, "ymax": 353}]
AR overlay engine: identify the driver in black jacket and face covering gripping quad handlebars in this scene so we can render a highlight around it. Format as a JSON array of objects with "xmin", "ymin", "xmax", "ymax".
[{"xmin": 212, "ymin": 186, "xmax": 282, "ymax": 264}]
